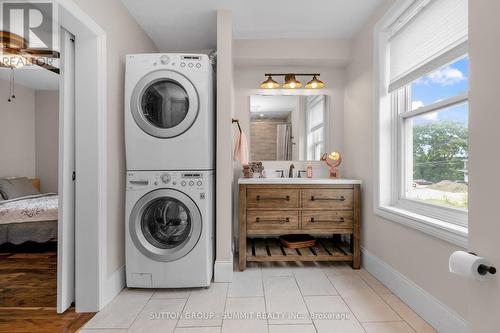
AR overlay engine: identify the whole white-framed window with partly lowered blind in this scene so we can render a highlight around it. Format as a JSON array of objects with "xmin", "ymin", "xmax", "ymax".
[{"xmin": 375, "ymin": 0, "xmax": 469, "ymax": 246}]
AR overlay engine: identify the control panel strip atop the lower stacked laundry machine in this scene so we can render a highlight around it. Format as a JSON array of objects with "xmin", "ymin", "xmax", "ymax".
[{"xmin": 127, "ymin": 171, "xmax": 204, "ymax": 190}]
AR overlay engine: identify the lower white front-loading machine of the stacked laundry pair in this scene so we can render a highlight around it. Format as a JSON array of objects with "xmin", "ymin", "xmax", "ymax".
[{"xmin": 125, "ymin": 171, "xmax": 215, "ymax": 288}]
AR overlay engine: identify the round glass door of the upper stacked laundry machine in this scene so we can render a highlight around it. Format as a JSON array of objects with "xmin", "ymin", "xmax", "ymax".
[{"xmin": 130, "ymin": 70, "xmax": 199, "ymax": 138}]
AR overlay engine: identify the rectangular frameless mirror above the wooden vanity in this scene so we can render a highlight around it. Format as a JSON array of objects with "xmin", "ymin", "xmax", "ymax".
[{"xmin": 250, "ymin": 95, "xmax": 330, "ymax": 161}]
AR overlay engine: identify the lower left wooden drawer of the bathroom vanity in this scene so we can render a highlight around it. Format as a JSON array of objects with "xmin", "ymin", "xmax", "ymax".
[{"xmin": 247, "ymin": 210, "xmax": 299, "ymax": 231}]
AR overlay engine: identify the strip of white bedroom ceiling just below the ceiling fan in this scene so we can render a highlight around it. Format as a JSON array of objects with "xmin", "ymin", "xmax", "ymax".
[{"xmin": 0, "ymin": 66, "xmax": 59, "ymax": 90}]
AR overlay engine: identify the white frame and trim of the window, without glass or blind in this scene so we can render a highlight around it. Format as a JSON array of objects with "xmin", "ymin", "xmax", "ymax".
[{"xmin": 373, "ymin": 0, "xmax": 468, "ymax": 247}]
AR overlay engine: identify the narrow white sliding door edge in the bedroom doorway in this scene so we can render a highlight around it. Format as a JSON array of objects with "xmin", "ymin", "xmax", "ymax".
[{"xmin": 57, "ymin": 29, "xmax": 75, "ymax": 313}]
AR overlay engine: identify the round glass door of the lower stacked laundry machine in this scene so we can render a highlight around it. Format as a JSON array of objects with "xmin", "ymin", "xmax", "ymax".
[{"xmin": 129, "ymin": 189, "xmax": 202, "ymax": 261}]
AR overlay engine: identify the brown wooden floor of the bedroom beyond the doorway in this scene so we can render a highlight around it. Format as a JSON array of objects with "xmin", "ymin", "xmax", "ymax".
[{"xmin": 0, "ymin": 243, "xmax": 93, "ymax": 333}]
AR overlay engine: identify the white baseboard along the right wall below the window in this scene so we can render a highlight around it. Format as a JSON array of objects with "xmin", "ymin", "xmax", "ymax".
[{"xmin": 361, "ymin": 248, "xmax": 467, "ymax": 333}]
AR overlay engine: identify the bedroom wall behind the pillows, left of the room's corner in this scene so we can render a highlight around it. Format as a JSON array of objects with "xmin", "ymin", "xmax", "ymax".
[{"xmin": 0, "ymin": 80, "xmax": 36, "ymax": 177}]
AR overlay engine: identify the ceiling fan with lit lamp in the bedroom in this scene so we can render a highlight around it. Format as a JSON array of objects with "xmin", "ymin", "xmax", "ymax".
[{"xmin": 0, "ymin": 31, "xmax": 60, "ymax": 74}]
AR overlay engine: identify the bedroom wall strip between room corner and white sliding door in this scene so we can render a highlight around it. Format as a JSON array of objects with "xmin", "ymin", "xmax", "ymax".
[{"xmin": 35, "ymin": 90, "xmax": 59, "ymax": 193}]
